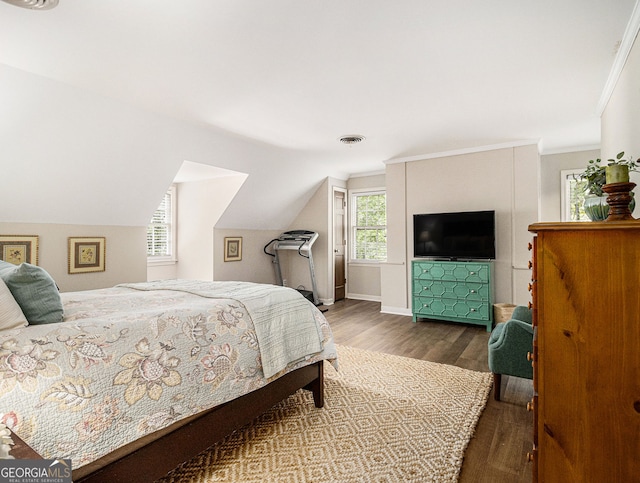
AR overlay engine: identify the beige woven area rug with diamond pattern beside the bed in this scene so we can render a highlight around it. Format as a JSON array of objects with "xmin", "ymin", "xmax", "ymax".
[{"xmin": 161, "ymin": 346, "xmax": 491, "ymax": 483}]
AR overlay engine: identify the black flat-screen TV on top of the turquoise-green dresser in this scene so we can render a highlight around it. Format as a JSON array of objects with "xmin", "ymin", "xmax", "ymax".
[{"xmin": 413, "ymin": 211, "xmax": 496, "ymax": 260}]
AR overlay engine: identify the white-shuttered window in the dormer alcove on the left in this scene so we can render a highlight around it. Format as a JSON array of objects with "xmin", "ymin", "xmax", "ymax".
[{"xmin": 147, "ymin": 186, "xmax": 176, "ymax": 263}]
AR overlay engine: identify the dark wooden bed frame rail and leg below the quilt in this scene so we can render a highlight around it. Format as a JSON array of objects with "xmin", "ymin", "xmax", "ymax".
[{"xmin": 11, "ymin": 361, "xmax": 324, "ymax": 483}]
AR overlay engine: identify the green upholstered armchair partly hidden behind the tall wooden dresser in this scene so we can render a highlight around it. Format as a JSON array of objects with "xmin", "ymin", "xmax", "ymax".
[{"xmin": 489, "ymin": 305, "xmax": 533, "ymax": 401}]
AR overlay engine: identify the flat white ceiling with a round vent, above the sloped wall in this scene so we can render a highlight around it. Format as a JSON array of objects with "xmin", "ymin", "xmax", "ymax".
[{"xmin": 0, "ymin": 0, "xmax": 635, "ymax": 173}]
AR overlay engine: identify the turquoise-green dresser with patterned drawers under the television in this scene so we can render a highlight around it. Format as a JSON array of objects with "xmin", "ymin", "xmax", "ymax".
[{"xmin": 411, "ymin": 260, "xmax": 493, "ymax": 332}]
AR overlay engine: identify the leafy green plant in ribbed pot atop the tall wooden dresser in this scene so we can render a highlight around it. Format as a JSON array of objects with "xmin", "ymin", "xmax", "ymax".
[{"xmin": 580, "ymin": 151, "xmax": 638, "ymax": 221}]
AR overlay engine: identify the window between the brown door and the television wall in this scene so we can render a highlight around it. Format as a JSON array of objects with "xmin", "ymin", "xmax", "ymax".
[{"xmin": 351, "ymin": 190, "xmax": 387, "ymax": 261}]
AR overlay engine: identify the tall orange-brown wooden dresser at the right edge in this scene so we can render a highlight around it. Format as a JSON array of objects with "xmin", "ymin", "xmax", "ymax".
[{"xmin": 529, "ymin": 221, "xmax": 640, "ymax": 483}]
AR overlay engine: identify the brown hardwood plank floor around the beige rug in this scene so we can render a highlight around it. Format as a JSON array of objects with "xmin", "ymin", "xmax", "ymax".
[{"xmin": 324, "ymin": 299, "xmax": 533, "ymax": 483}]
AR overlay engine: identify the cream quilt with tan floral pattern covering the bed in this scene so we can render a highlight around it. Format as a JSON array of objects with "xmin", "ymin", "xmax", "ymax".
[{"xmin": 0, "ymin": 282, "xmax": 337, "ymax": 469}]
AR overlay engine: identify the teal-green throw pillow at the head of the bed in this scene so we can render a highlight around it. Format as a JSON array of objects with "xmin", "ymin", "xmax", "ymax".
[{"xmin": 0, "ymin": 260, "xmax": 64, "ymax": 325}]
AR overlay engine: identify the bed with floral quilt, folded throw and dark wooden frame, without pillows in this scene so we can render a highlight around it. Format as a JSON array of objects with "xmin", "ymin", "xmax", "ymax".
[{"xmin": 0, "ymin": 272, "xmax": 337, "ymax": 482}]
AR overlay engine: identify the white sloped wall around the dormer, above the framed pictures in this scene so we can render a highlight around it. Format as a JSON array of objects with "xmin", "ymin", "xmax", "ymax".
[{"xmin": 0, "ymin": 64, "xmax": 341, "ymax": 233}]
